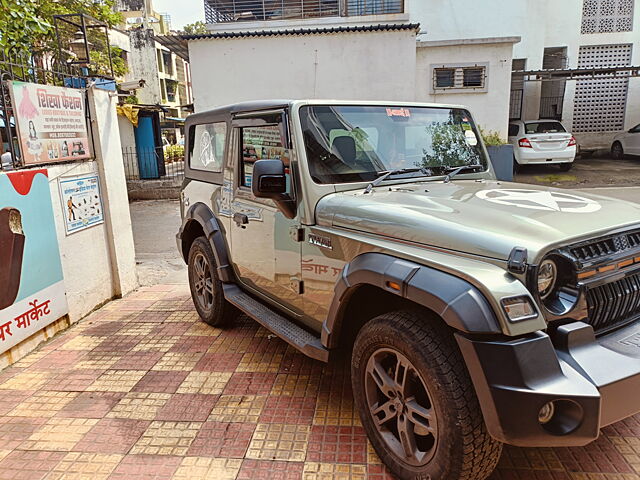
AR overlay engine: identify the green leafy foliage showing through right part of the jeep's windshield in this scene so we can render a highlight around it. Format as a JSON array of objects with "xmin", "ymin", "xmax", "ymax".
[{"xmin": 417, "ymin": 122, "xmax": 479, "ymax": 168}]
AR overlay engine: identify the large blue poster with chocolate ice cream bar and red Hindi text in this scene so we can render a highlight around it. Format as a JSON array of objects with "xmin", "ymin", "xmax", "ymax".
[{"xmin": 0, "ymin": 170, "xmax": 68, "ymax": 353}]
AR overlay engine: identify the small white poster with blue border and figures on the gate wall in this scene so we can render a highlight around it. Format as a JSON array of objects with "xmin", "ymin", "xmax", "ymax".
[{"xmin": 59, "ymin": 174, "xmax": 104, "ymax": 235}]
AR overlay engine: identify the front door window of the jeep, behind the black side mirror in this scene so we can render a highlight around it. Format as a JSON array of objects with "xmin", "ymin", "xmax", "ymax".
[{"xmin": 240, "ymin": 125, "xmax": 289, "ymax": 188}]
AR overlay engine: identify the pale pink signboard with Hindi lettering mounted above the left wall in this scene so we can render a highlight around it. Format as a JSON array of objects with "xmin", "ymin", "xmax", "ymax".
[{"xmin": 9, "ymin": 81, "xmax": 91, "ymax": 165}]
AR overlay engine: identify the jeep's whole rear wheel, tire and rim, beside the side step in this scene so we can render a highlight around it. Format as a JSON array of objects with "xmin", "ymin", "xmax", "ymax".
[{"xmin": 188, "ymin": 237, "xmax": 239, "ymax": 327}]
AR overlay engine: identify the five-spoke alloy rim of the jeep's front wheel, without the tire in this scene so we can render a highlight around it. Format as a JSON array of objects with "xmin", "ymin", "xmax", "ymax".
[{"xmin": 365, "ymin": 348, "xmax": 438, "ymax": 467}]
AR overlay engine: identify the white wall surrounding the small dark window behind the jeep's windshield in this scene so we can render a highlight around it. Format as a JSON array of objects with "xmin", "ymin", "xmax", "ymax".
[{"xmin": 415, "ymin": 43, "xmax": 513, "ymax": 139}]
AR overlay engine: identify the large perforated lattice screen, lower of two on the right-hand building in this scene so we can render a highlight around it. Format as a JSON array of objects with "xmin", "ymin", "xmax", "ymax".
[{"xmin": 573, "ymin": 44, "xmax": 631, "ymax": 133}]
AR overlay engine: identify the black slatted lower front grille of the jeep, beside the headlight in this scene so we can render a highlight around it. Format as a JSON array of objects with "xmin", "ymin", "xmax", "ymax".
[{"xmin": 587, "ymin": 273, "xmax": 640, "ymax": 332}]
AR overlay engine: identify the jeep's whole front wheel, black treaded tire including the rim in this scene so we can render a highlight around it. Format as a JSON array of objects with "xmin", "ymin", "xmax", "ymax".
[{"xmin": 351, "ymin": 311, "xmax": 502, "ymax": 480}]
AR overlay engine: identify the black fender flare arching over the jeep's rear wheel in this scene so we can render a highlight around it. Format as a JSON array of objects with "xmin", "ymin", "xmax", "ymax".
[{"xmin": 176, "ymin": 202, "xmax": 235, "ymax": 282}]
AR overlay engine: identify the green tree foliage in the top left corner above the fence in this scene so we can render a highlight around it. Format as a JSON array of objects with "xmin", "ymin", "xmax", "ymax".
[{"xmin": 0, "ymin": 0, "xmax": 122, "ymax": 73}]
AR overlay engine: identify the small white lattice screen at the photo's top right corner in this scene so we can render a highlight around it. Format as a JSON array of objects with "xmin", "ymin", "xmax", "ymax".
[{"xmin": 581, "ymin": 0, "xmax": 634, "ymax": 33}]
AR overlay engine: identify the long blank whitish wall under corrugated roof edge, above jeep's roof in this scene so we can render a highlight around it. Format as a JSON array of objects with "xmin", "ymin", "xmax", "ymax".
[{"xmin": 189, "ymin": 31, "xmax": 416, "ymax": 111}]
